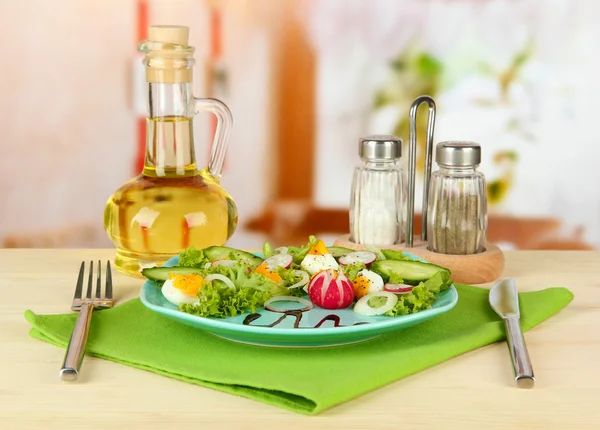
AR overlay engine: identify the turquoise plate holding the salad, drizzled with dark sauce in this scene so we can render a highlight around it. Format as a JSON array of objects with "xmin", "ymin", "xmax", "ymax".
[{"xmin": 140, "ymin": 250, "xmax": 458, "ymax": 348}]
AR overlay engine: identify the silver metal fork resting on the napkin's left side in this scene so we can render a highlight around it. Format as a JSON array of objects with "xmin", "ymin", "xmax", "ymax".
[{"xmin": 60, "ymin": 261, "xmax": 113, "ymax": 381}]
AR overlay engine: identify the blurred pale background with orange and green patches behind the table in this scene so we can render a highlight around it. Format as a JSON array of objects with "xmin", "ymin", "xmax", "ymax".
[{"xmin": 0, "ymin": 0, "xmax": 600, "ymax": 249}]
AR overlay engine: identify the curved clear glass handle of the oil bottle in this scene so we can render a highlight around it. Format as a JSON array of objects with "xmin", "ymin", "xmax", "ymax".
[{"xmin": 194, "ymin": 97, "xmax": 233, "ymax": 182}]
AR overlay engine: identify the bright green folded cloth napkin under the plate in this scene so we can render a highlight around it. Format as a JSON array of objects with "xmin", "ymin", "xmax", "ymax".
[{"xmin": 25, "ymin": 285, "xmax": 573, "ymax": 414}]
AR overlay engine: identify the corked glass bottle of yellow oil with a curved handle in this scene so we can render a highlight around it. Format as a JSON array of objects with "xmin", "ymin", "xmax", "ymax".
[{"xmin": 104, "ymin": 26, "xmax": 238, "ymax": 276}]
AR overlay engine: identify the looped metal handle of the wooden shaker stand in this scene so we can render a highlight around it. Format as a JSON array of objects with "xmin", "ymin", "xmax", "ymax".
[{"xmin": 406, "ymin": 96, "xmax": 435, "ymax": 248}]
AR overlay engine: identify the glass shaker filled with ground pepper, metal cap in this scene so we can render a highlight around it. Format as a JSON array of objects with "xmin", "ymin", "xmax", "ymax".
[{"xmin": 427, "ymin": 141, "xmax": 487, "ymax": 254}]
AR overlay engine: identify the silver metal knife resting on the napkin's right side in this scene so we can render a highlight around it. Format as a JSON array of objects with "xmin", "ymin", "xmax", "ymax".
[{"xmin": 490, "ymin": 278, "xmax": 534, "ymax": 388}]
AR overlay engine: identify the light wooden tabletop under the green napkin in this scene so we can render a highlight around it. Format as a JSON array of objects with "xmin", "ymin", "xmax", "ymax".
[{"xmin": 0, "ymin": 250, "xmax": 600, "ymax": 430}]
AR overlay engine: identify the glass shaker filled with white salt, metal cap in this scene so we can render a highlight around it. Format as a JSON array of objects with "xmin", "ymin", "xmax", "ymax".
[{"xmin": 350, "ymin": 135, "xmax": 405, "ymax": 245}]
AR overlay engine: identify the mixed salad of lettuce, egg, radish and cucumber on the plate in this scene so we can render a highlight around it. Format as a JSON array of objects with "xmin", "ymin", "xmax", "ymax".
[{"xmin": 142, "ymin": 236, "xmax": 452, "ymax": 318}]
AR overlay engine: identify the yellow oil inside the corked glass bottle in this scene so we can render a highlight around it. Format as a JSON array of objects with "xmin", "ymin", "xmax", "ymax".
[{"xmin": 104, "ymin": 117, "xmax": 238, "ymax": 276}]
